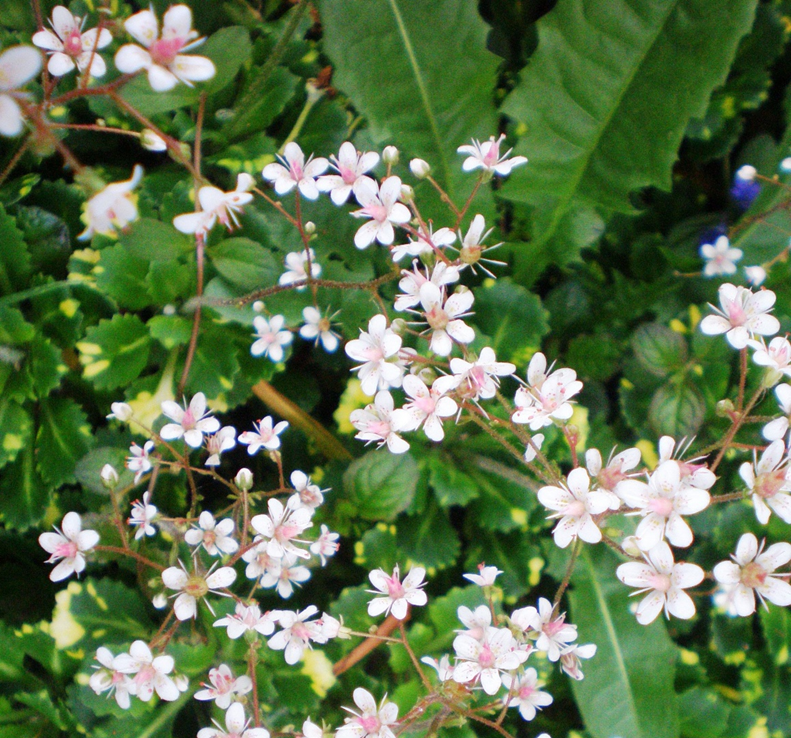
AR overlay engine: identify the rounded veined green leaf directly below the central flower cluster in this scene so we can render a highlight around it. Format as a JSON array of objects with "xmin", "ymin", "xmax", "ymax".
[{"xmin": 343, "ymin": 450, "xmax": 420, "ymax": 520}]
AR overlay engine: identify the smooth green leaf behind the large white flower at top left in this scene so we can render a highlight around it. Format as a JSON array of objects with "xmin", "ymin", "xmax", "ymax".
[{"xmin": 122, "ymin": 26, "xmax": 252, "ymax": 116}]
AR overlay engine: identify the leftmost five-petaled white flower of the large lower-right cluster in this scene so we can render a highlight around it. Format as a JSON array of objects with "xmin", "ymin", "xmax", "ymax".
[{"xmin": 538, "ymin": 467, "xmax": 610, "ymax": 548}]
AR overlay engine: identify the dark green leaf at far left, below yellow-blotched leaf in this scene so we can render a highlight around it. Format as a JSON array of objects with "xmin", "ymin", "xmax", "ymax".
[{"xmin": 36, "ymin": 397, "xmax": 95, "ymax": 487}]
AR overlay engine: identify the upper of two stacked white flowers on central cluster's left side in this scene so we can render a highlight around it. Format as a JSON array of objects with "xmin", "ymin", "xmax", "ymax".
[{"xmin": 346, "ymin": 315, "xmax": 404, "ymax": 396}]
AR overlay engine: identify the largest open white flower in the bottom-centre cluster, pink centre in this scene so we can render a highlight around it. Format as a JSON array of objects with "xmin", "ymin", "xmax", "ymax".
[{"xmin": 453, "ymin": 628, "xmax": 528, "ymax": 695}]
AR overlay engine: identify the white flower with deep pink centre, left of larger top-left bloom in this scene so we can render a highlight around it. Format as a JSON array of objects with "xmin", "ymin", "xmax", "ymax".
[{"xmin": 33, "ymin": 5, "xmax": 113, "ymax": 77}]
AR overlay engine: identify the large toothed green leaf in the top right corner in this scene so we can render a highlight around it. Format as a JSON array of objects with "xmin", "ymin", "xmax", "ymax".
[{"xmin": 503, "ymin": 0, "xmax": 756, "ymax": 261}]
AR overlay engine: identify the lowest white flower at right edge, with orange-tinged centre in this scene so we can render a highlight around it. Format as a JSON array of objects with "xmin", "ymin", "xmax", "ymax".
[{"xmin": 714, "ymin": 533, "xmax": 791, "ymax": 617}]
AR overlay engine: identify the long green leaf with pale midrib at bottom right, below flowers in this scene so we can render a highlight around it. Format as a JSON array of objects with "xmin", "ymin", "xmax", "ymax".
[{"xmin": 569, "ymin": 546, "xmax": 679, "ymax": 738}]
